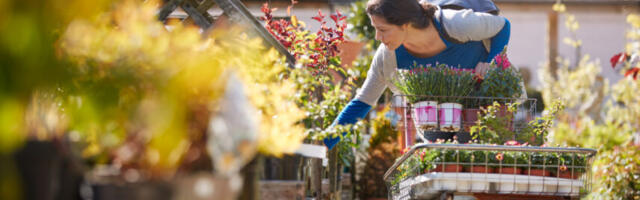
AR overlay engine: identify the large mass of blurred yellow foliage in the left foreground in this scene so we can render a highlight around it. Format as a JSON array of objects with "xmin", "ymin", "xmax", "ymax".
[{"xmin": 53, "ymin": 1, "xmax": 304, "ymax": 175}]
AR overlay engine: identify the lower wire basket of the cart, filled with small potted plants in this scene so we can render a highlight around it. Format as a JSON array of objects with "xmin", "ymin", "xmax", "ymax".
[{"xmin": 384, "ymin": 143, "xmax": 596, "ymax": 199}]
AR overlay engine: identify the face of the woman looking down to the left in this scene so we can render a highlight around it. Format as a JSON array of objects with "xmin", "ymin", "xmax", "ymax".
[{"xmin": 369, "ymin": 15, "xmax": 406, "ymax": 50}]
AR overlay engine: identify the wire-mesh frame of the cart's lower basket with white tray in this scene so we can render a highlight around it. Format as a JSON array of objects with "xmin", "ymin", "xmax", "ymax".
[{"xmin": 384, "ymin": 143, "xmax": 596, "ymax": 199}]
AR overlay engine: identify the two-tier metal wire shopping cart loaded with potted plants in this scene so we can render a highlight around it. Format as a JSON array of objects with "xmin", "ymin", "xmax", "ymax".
[{"xmin": 384, "ymin": 96, "xmax": 596, "ymax": 199}]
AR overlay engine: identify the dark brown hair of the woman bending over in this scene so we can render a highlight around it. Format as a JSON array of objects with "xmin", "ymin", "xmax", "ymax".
[{"xmin": 367, "ymin": 0, "xmax": 437, "ymax": 29}]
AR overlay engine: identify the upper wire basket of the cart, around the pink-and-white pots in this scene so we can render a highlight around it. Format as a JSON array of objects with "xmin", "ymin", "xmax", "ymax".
[{"xmin": 392, "ymin": 95, "xmax": 543, "ymax": 146}]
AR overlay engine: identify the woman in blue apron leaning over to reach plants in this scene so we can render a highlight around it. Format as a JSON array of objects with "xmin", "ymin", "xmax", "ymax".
[{"xmin": 324, "ymin": 0, "xmax": 510, "ymax": 148}]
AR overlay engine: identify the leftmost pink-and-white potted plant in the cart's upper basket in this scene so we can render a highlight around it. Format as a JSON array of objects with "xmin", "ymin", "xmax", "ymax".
[{"xmin": 394, "ymin": 64, "xmax": 439, "ymax": 132}]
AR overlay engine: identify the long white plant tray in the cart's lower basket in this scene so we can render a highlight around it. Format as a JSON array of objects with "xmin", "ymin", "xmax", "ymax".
[{"xmin": 391, "ymin": 172, "xmax": 584, "ymax": 199}]
